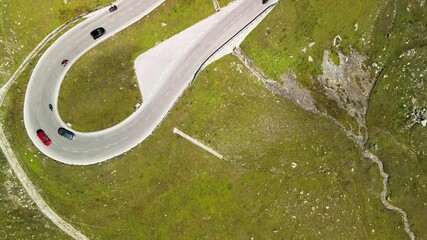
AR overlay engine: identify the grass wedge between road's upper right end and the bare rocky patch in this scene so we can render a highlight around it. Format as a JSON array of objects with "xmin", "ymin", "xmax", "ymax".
[{"xmin": 242, "ymin": 0, "xmax": 383, "ymax": 135}]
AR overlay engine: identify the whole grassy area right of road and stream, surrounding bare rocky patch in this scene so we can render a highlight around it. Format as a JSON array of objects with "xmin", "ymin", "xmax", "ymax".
[{"xmin": 242, "ymin": 0, "xmax": 427, "ymax": 238}]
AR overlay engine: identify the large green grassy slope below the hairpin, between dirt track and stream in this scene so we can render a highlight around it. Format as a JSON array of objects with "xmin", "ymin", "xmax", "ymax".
[{"xmin": 2, "ymin": 52, "xmax": 405, "ymax": 239}]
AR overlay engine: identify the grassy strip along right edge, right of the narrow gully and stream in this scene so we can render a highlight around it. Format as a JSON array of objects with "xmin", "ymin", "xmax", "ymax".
[{"xmin": 367, "ymin": 1, "xmax": 427, "ymax": 236}]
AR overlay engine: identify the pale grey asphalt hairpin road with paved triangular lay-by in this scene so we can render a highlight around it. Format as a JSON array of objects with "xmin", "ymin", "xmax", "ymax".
[{"xmin": 24, "ymin": 0, "xmax": 277, "ymax": 165}]
